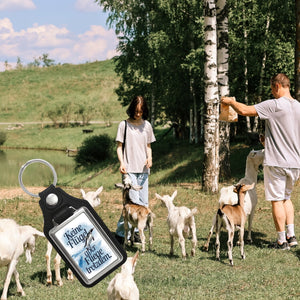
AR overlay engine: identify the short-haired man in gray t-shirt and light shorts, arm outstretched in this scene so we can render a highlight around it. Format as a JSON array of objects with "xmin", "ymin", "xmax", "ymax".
[{"xmin": 221, "ymin": 73, "xmax": 300, "ymax": 250}]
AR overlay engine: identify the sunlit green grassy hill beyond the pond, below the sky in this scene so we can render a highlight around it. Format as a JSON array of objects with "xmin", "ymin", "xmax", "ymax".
[{"xmin": 0, "ymin": 60, "xmax": 124, "ymax": 122}]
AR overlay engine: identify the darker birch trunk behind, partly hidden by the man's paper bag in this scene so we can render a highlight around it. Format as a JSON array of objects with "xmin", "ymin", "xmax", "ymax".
[{"xmin": 217, "ymin": 0, "xmax": 231, "ymax": 178}]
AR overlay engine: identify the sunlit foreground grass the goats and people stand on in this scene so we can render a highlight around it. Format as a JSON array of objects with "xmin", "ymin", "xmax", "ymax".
[{"xmin": 0, "ymin": 182, "xmax": 300, "ymax": 300}]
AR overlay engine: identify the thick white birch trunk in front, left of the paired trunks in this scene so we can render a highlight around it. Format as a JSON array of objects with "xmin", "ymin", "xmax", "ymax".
[{"xmin": 202, "ymin": 0, "xmax": 219, "ymax": 193}]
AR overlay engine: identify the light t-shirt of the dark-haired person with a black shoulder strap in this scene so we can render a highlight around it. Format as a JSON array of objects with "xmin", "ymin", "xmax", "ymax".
[{"xmin": 116, "ymin": 121, "xmax": 155, "ymax": 173}]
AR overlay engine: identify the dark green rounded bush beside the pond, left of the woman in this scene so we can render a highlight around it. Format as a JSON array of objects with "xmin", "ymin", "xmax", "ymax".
[{"xmin": 75, "ymin": 134, "xmax": 114, "ymax": 167}]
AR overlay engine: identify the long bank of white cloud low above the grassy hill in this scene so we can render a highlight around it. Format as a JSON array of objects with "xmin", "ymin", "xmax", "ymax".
[{"xmin": 0, "ymin": 18, "xmax": 117, "ymax": 65}]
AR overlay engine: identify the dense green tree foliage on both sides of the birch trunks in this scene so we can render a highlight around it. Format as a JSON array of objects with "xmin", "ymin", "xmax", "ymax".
[{"xmin": 96, "ymin": 0, "xmax": 296, "ymax": 136}]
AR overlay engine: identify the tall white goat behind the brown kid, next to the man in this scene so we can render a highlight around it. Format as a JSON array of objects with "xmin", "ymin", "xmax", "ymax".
[{"xmin": 219, "ymin": 149, "xmax": 265, "ymax": 243}]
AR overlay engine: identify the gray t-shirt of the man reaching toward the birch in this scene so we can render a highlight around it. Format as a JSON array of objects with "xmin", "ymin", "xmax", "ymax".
[{"xmin": 254, "ymin": 97, "xmax": 300, "ymax": 168}]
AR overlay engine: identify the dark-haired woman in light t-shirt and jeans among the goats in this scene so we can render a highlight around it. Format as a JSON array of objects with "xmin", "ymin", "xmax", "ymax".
[{"xmin": 116, "ymin": 96, "xmax": 155, "ymax": 243}]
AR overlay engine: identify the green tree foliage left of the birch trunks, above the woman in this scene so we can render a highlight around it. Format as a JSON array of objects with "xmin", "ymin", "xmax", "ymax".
[{"xmin": 97, "ymin": 0, "xmax": 204, "ymax": 127}]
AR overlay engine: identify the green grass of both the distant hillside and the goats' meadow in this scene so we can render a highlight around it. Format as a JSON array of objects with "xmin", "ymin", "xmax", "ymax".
[{"xmin": 0, "ymin": 61, "xmax": 300, "ymax": 300}]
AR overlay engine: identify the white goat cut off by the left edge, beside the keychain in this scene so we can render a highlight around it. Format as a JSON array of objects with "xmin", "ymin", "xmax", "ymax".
[{"xmin": 0, "ymin": 219, "xmax": 44, "ymax": 300}]
